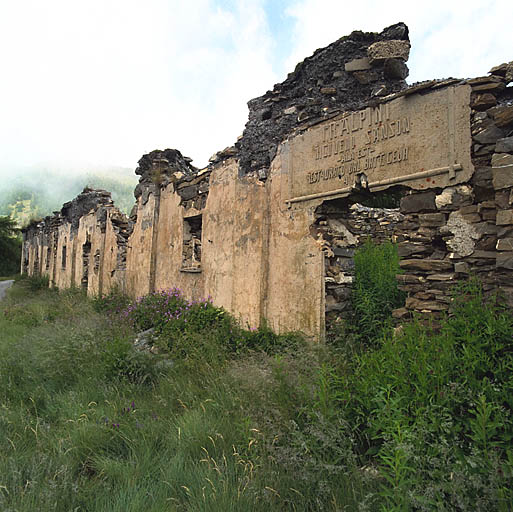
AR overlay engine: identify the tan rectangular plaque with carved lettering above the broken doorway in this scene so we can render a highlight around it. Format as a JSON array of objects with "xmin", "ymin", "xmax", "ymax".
[{"xmin": 284, "ymin": 85, "xmax": 473, "ymax": 203}]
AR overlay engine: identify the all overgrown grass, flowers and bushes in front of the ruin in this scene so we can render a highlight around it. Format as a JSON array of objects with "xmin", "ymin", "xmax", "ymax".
[{"xmin": 0, "ymin": 246, "xmax": 513, "ymax": 512}]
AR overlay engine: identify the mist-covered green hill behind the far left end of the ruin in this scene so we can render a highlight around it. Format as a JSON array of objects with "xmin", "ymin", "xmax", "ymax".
[{"xmin": 0, "ymin": 166, "xmax": 138, "ymax": 226}]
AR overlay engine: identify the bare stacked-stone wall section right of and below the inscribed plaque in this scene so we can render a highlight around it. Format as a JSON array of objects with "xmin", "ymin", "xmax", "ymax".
[{"xmin": 395, "ymin": 68, "xmax": 513, "ymax": 318}]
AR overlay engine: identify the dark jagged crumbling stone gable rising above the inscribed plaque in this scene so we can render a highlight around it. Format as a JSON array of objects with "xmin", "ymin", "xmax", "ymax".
[{"xmin": 235, "ymin": 23, "xmax": 410, "ymax": 179}]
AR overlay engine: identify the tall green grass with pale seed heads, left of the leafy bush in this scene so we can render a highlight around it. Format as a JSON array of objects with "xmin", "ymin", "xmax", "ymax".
[{"xmin": 0, "ymin": 284, "xmax": 359, "ymax": 512}]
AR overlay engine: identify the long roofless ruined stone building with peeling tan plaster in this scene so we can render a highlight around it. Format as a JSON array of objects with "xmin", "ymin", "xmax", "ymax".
[{"xmin": 22, "ymin": 23, "xmax": 513, "ymax": 337}]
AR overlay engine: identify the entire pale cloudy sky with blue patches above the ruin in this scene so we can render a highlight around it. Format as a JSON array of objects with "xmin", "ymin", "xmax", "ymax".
[{"xmin": 0, "ymin": 0, "xmax": 513, "ymax": 176}]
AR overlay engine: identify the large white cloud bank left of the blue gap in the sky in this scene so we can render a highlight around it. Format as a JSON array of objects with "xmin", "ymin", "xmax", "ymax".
[{"xmin": 0, "ymin": 0, "xmax": 275, "ymax": 172}]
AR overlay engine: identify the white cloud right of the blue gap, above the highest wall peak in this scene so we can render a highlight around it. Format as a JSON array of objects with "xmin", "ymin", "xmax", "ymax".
[{"xmin": 287, "ymin": 0, "xmax": 513, "ymax": 82}]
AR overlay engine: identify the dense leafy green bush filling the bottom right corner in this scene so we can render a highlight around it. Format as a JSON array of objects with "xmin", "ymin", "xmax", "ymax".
[{"xmin": 340, "ymin": 281, "xmax": 513, "ymax": 510}]
